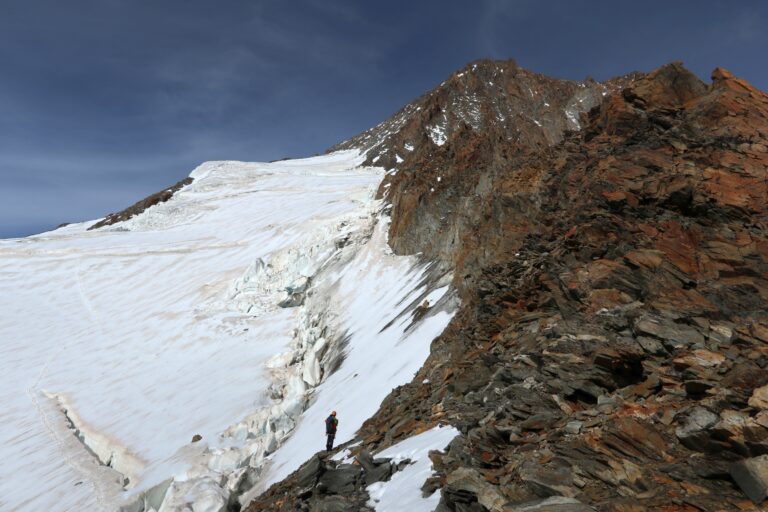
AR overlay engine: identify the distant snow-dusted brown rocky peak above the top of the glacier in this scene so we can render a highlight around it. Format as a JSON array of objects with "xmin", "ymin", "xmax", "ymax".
[{"xmin": 329, "ymin": 59, "xmax": 636, "ymax": 168}]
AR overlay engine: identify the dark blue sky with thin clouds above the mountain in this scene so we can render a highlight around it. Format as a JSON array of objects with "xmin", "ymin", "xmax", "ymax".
[{"xmin": 0, "ymin": 0, "xmax": 768, "ymax": 238}]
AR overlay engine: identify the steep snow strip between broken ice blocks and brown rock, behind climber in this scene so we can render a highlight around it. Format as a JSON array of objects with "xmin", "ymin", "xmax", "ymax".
[{"xmin": 249, "ymin": 222, "xmax": 454, "ymax": 497}]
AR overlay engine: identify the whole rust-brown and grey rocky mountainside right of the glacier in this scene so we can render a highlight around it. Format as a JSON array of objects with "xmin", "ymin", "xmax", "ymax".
[{"xmin": 246, "ymin": 58, "xmax": 768, "ymax": 511}]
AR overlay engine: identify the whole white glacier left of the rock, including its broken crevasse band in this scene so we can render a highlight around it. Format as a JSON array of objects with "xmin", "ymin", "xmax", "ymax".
[{"xmin": 0, "ymin": 151, "xmax": 455, "ymax": 512}]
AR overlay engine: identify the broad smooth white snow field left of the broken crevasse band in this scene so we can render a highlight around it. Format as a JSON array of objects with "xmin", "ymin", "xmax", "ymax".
[{"xmin": 0, "ymin": 152, "xmax": 374, "ymax": 510}]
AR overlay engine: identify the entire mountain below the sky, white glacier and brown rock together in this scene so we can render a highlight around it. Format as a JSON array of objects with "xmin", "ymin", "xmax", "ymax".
[{"xmin": 0, "ymin": 57, "xmax": 768, "ymax": 512}]
